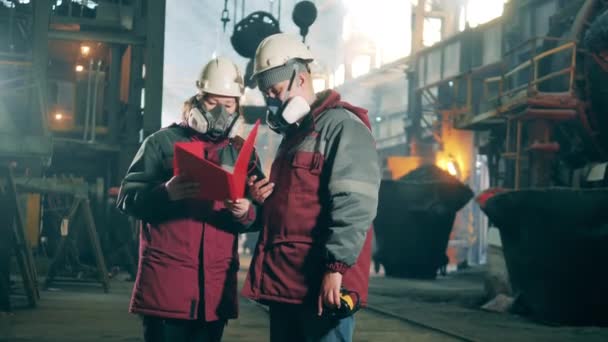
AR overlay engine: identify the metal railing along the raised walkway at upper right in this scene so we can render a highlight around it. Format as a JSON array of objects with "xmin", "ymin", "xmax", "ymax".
[{"xmin": 417, "ymin": 37, "xmax": 579, "ymax": 134}]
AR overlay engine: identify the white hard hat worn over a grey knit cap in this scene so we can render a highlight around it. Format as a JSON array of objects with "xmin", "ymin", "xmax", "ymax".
[{"xmin": 251, "ymin": 33, "xmax": 314, "ymax": 78}]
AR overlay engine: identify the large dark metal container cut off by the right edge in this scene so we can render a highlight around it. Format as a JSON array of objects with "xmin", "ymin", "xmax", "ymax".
[{"xmin": 483, "ymin": 188, "xmax": 608, "ymax": 326}]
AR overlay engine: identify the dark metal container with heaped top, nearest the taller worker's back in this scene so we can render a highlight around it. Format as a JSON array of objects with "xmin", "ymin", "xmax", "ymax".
[{"xmin": 374, "ymin": 167, "xmax": 473, "ymax": 279}]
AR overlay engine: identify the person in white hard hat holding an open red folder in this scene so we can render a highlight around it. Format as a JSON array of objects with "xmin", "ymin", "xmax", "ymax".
[{"xmin": 117, "ymin": 58, "xmax": 263, "ymax": 341}]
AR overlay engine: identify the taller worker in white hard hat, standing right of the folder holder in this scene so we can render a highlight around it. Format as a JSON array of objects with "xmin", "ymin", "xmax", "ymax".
[{"xmin": 243, "ymin": 34, "xmax": 380, "ymax": 341}]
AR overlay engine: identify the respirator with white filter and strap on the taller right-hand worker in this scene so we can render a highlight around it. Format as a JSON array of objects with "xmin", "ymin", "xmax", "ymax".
[{"xmin": 266, "ymin": 66, "xmax": 310, "ymax": 134}]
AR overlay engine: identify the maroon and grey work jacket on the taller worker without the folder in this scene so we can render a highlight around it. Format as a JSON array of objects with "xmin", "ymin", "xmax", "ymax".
[{"xmin": 243, "ymin": 91, "xmax": 381, "ymax": 305}]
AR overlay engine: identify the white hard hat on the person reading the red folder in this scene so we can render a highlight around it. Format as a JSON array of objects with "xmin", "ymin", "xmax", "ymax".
[{"xmin": 196, "ymin": 57, "xmax": 245, "ymax": 97}]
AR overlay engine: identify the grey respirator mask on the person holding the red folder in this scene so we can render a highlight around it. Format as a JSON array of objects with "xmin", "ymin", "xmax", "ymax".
[{"xmin": 188, "ymin": 102, "xmax": 239, "ymax": 140}]
